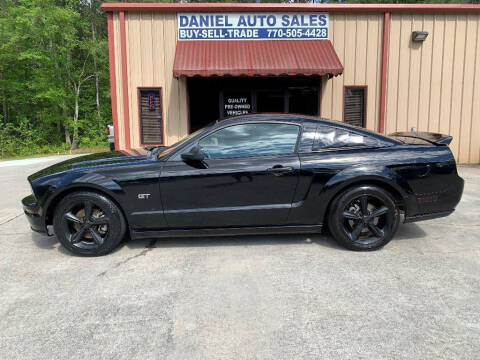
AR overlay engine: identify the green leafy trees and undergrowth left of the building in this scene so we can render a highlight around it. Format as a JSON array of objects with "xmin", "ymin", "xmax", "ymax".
[{"xmin": 0, "ymin": 0, "xmax": 111, "ymax": 157}]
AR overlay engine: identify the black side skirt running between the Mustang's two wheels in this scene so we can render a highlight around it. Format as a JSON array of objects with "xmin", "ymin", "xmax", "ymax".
[{"xmin": 131, "ymin": 224, "xmax": 322, "ymax": 239}]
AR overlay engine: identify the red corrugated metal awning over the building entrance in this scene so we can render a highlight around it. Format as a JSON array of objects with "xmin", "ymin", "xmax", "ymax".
[{"xmin": 173, "ymin": 40, "xmax": 343, "ymax": 77}]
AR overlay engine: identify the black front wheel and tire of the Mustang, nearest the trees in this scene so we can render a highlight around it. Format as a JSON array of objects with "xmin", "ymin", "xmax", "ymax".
[{"xmin": 53, "ymin": 191, "xmax": 127, "ymax": 256}]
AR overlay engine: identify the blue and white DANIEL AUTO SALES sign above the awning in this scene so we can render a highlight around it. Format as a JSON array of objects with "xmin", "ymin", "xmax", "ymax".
[{"xmin": 177, "ymin": 13, "xmax": 328, "ymax": 40}]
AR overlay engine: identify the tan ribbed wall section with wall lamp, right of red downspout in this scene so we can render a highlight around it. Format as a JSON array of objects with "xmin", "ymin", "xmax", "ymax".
[{"xmin": 385, "ymin": 14, "xmax": 480, "ymax": 163}]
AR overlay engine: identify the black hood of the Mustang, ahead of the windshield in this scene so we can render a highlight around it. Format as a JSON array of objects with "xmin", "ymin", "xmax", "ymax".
[{"xmin": 28, "ymin": 151, "xmax": 147, "ymax": 182}]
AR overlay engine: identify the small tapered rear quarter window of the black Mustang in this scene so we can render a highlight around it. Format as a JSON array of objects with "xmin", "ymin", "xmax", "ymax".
[{"xmin": 313, "ymin": 126, "xmax": 377, "ymax": 150}]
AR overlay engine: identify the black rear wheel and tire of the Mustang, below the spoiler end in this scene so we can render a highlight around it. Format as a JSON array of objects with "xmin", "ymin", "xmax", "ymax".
[{"xmin": 328, "ymin": 185, "xmax": 400, "ymax": 250}]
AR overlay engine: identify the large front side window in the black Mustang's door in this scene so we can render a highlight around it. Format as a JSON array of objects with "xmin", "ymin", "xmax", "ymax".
[{"xmin": 198, "ymin": 123, "xmax": 300, "ymax": 159}]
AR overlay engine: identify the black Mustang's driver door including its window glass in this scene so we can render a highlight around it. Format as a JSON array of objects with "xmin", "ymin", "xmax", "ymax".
[{"xmin": 160, "ymin": 123, "xmax": 300, "ymax": 228}]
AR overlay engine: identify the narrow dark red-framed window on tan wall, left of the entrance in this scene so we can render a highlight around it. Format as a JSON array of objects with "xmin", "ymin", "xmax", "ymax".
[{"xmin": 140, "ymin": 89, "xmax": 163, "ymax": 145}]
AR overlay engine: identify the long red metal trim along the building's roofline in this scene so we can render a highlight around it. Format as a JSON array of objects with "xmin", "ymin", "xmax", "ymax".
[{"xmin": 101, "ymin": 3, "xmax": 480, "ymax": 13}]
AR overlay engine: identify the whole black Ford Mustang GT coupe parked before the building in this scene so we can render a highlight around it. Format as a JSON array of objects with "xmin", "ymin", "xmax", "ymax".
[{"xmin": 23, "ymin": 115, "xmax": 463, "ymax": 255}]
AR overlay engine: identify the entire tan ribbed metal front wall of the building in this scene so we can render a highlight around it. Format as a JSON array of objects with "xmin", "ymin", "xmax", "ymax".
[{"xmin": 113, "ymin": 12, "xmax": 480, "ymax": 163}]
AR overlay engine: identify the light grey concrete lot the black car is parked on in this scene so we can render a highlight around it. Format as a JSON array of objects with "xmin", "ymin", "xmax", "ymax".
[{"xmin": 0, "ymin": 157, "xmax": 480, "ymax": 359}]
